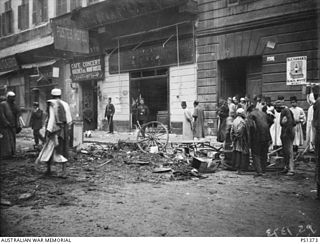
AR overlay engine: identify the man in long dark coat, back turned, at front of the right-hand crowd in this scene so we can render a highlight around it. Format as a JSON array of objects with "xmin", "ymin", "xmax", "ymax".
[{"xmin": 248, "ymin": 106, "xmax": 271, "ymax": 176}]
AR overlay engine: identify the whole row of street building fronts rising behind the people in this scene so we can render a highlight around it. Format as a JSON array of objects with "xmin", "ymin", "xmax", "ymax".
[{"xmin": 0, "ymin": 0, "xmax": 320, "ymax": 135}]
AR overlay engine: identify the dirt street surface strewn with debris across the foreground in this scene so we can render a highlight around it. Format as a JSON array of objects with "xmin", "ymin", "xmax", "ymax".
[{"xmin": 1, "ymin": 141, "xmax": 320, "ymax": 237}]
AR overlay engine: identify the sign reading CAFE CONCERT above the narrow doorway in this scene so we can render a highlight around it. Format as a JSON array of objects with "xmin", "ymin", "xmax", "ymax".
[{"xmin": 70, "ymin": 56, "xmax": 104, "ymax": 81}]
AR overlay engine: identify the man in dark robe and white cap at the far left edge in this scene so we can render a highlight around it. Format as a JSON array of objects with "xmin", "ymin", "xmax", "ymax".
[{"xmin": 0, "ymin": 91, "xmax": 21, "ymax": 158}]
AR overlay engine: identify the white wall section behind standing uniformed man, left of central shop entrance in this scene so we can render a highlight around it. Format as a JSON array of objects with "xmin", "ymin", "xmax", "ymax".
[{"xmin": 98, "ymin": 56, "xmax": 130, "ymax": 128}]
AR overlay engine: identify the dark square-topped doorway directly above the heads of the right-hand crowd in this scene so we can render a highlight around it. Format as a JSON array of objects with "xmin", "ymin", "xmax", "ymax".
[{"xmin": 218, "ymin": 57, "xmax": 262, "ymax": 99}]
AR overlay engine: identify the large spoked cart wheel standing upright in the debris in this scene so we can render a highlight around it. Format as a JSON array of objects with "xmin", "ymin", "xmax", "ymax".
[{"xmin": 137, "ymin": 121, "xmax": 169, "ymax": 152}]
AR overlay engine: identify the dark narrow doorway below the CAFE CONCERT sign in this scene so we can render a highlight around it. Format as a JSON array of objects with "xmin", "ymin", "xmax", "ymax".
[{"xmin": 80, "ymin": 81, "xmax": 98, "ymax": 131}]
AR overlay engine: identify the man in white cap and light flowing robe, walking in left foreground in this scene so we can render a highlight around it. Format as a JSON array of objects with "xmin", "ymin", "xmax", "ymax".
[{"xmin": 36, "ymin": 88, "xmax": 72, "ymax": 175}]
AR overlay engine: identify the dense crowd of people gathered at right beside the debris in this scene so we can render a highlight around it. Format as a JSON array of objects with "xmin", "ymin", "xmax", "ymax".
[{"xmin": 217, "ymin": 86, "xmax": 320, "ymax": 197}]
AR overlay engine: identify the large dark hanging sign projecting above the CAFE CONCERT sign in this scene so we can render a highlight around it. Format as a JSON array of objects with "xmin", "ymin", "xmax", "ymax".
[{"xmin": 52, "ymin": 25, "xmax": 89, "ymax": 53}]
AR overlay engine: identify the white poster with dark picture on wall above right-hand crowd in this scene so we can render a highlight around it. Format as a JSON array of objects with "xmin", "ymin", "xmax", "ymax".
[{"xmin": 287, "ymin": 56, "xmax": 307, "ymax": 86}]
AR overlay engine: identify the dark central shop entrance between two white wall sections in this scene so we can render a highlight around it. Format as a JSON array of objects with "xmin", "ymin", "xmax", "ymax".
[{"xmin": 130, "ymin": 69, "xmax": 170, "ymax": 129}]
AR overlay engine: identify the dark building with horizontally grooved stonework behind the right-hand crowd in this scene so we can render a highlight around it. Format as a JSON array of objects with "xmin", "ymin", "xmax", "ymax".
[{"xmin": 197, "ymin": 0, "xmax": 320, "ymax": 133}]
